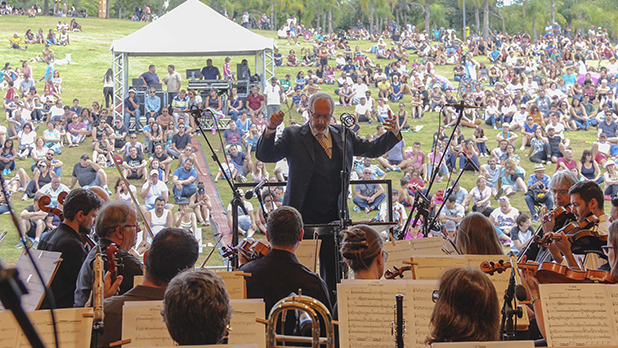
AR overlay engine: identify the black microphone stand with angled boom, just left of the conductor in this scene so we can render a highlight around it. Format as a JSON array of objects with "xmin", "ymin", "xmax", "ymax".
[{"xmin": 191, "ymin": 105, "xmax": 248, "ymax": 270}]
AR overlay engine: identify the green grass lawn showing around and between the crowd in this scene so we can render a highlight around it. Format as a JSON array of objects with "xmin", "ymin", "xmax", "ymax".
[{"xmin": 0, "ymin": 16, "xmax": 609, "ymax": 265}]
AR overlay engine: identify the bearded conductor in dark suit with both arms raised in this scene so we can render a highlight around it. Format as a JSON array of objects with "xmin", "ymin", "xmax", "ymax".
[{"xmin": 256, "ymin": 92, "xmax": 401, "ymax": 290}]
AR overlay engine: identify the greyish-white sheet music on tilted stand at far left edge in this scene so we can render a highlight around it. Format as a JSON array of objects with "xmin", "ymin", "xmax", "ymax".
[{"xmin": 0, "ymin": 249, "xmax": 62, "ymax": 312}]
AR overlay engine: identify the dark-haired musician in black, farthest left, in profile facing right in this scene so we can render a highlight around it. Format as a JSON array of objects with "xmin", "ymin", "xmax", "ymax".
[{"xmin": 39, "ymin": 188, "xmax": 103, "ymax": 309}]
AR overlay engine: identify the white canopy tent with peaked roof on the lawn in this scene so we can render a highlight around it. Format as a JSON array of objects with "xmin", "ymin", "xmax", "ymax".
[{"xmin": 110, "ymin": 0, "xmax": 275, "ymax": 121}]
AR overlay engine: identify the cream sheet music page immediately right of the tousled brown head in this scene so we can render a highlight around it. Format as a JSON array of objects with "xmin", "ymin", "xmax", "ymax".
[{"xmin": 229, "ymin": 299, "xmax": 266, "ymax": 348}]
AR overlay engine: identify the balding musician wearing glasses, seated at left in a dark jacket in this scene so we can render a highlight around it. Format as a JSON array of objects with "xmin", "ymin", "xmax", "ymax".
[{"xmin": 75, "ymin": 201, "xmax": 144, "ymax": 307}]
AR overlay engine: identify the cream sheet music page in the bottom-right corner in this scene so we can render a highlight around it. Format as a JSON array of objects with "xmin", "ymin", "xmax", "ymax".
[{"xmin": 539, "ymin": 284, "xmax": 616, "ymax": 347}]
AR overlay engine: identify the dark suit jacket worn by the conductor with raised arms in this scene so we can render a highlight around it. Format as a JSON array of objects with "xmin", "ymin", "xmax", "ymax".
[{"xmin": 256, "ymin": 123, "xmax": 400, "ymax": 223}]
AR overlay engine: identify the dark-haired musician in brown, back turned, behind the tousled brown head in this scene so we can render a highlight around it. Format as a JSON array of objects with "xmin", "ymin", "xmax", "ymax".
[{"xmin": 98, "ymin": 228, "xmax": 198, "ymax": 347}]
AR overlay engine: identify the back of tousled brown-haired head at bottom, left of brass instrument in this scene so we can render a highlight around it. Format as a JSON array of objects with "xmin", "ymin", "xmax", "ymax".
[{"xmin": 161, "ymin": 269, "xmax": 233, "ymax": 345}]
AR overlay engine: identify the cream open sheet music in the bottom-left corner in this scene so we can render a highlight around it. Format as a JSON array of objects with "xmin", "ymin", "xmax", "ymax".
[{"xmin": 15, "ymin": 308, "xmax": 92, "ymax": 348}]
